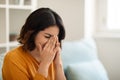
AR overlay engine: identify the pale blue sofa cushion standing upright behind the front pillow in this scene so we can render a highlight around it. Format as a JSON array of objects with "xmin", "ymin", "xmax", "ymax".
[{"xmin": 62, "ymin": 38, "xmax": 98, "ymax": 69}]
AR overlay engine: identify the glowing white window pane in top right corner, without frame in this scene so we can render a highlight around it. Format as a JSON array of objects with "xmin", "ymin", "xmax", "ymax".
[{"xmin": 107, "ymin": 0, "xmax": 120, "ymax": 30}]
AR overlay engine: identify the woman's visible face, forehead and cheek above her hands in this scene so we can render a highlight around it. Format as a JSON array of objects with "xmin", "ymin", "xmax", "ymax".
[{"xmin": 35, "ymin": 26, "xmax": 59, "ymax": 48}]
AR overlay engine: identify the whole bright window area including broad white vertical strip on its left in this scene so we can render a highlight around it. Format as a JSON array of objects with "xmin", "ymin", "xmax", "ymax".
[{"xmin": 84, "ymin": 0, "xmax": 120, "ymax": 38}]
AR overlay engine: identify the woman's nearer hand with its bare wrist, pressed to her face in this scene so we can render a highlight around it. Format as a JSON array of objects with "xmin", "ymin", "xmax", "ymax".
[{"xmin": 38, "ymin": 37, "xmax": 58, "ymax": 77}]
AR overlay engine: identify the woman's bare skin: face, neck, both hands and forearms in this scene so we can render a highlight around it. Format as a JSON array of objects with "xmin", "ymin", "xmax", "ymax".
[{"xmin": 30, "ymin": 26, "xmax": 66, "ymax": 80}]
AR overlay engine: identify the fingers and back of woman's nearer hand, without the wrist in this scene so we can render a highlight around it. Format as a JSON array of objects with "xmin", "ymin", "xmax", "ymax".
[{"xmin": 41, "ymin": 36, "xmax": 58, "ymax": 63}]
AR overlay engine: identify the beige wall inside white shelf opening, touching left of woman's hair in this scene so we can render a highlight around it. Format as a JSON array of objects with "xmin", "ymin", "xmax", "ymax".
[{"xmin": 9, "ymin": 9, "xmax": 30, "ymax": 35}]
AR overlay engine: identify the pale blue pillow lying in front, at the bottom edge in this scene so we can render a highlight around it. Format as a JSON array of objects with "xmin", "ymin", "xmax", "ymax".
[{"xmin": 66, "ymin": 60, "xmax": 109, "ymax": 80}]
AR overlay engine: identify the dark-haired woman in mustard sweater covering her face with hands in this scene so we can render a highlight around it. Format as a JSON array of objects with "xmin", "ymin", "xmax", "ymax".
[{"xmin": 2, "ymin": 8, "xmax": 66, "ymax": 80}]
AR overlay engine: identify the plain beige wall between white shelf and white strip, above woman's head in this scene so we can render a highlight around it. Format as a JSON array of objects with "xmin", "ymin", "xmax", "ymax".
[{"xmin": 38, "ymin": 0, "xmax": 84, "ymax": 40}]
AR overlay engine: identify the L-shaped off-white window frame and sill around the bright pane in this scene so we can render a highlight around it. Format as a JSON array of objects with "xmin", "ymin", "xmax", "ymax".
[{"xmin": 93, "ymin": 0, "xmax": 120, "ymax": 38}]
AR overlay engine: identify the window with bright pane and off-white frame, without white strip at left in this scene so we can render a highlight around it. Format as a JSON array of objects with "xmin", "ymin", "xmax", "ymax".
[{"xmin": 93, "ymin": 0, "xmax": 120, "ymax": 38}]
